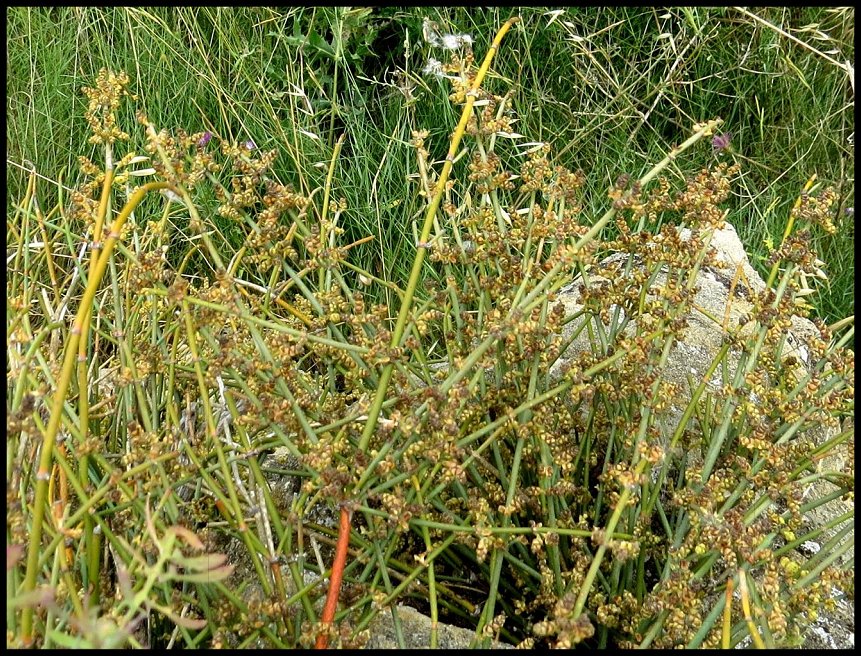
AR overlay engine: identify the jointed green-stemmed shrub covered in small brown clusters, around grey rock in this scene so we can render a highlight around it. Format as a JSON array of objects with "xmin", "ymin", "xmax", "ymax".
[{"xmin": 7, "ymin": 20, "xmax": 854, "ymax": 647}]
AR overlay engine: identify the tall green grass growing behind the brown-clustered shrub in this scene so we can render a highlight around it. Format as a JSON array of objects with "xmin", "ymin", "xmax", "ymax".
[{"xmin": 7, "ymin": 7, "xmax": 854, "ymax": 330}]
